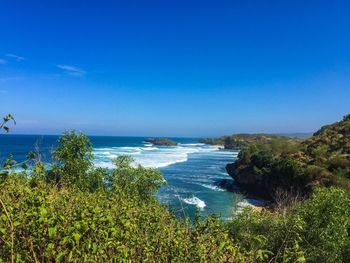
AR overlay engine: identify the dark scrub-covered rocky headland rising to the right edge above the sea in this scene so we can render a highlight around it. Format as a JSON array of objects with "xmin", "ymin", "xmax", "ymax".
[{"xmin": 226, "ymin": 115, "xmax": 350, "ymax": 198}]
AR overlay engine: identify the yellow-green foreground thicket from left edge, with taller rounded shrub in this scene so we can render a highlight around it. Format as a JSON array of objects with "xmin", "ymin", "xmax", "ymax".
[{"xmin": 0, "ymin": 132, "xmax": 248, "ymax": 262}]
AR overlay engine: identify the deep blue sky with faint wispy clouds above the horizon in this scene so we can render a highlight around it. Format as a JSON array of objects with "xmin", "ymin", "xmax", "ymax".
[{"xmin": 0, "ymin": 0, "xmax": 350, "ymax": 136}]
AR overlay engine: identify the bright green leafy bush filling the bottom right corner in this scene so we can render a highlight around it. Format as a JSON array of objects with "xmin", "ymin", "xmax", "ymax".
[{"xmin": 296, "ymin": 188, "xmax": 350, "ymax": 262}]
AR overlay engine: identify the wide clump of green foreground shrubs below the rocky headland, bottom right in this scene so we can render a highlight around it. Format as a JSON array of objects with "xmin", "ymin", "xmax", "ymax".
[{"xmin": 228, "ymin": 188, "xmax": 350, "ymax": 262}]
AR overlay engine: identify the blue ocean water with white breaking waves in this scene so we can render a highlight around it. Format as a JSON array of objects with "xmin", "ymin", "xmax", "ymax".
[{"xmin": 0, "ymin": 134, "xmax": 249, "ymax": 219}]
